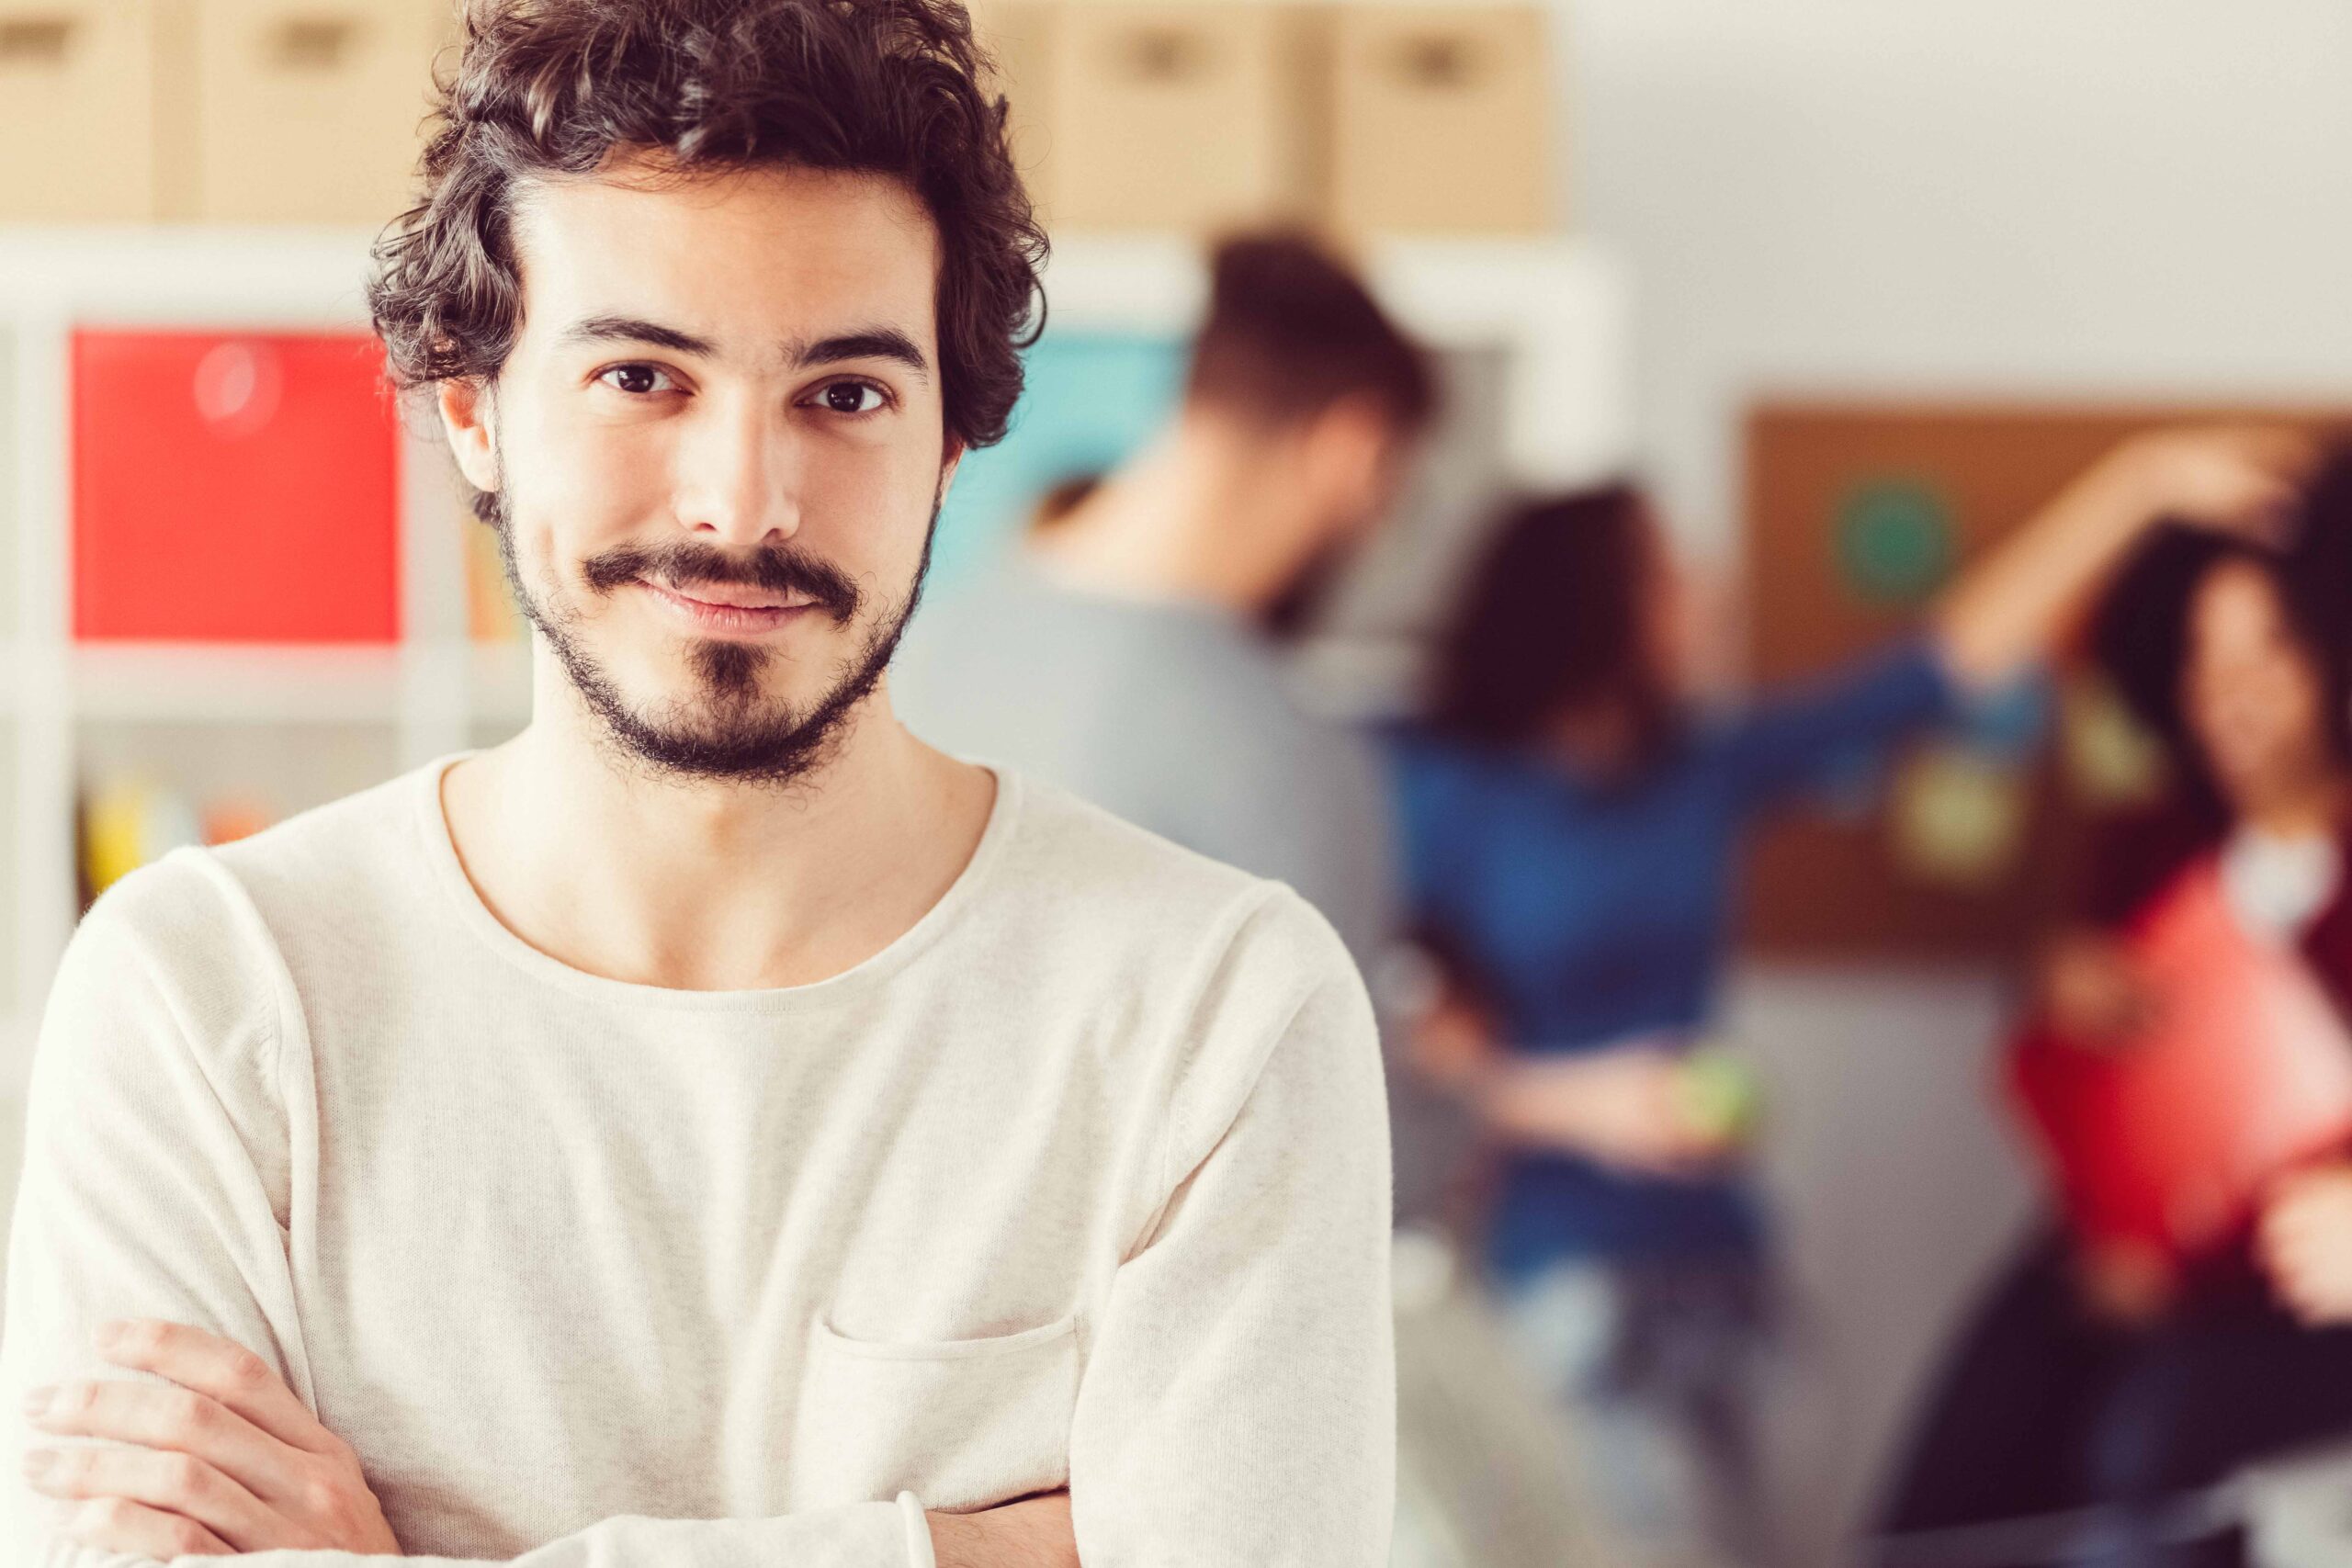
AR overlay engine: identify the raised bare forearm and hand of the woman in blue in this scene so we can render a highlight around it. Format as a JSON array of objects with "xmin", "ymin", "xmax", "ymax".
[{"xmin": 1931, "ymin": 428, "xmax": 2317, "ymax": 691}]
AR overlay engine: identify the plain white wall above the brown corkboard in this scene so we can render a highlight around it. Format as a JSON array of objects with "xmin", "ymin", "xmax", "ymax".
[{"xmin": 1564, "ymin": 0, "xmax": 2352, "ymax": 547}]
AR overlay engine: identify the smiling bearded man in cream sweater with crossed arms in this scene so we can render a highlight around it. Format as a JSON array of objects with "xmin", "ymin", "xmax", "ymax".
[{"xmin": 0, "ymin": 0, "xmax": 1395, "ymax": 1568}]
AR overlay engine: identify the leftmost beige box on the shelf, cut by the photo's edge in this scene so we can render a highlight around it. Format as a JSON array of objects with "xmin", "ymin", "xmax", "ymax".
[{"xmin": 0, "ymin": 0, "xmax": 163, "ymax": 223}]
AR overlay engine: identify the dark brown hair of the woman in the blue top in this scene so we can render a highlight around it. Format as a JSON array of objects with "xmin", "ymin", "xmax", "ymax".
[{"xmin": 1428, "ymin": 484, "xmax": 1679, "ymax": 771}]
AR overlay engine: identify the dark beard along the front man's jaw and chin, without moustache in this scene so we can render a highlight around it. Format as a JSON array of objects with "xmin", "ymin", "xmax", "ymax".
[{"xmin": 478, "ymin": 496, "xmax": 944, "ymax": 787}]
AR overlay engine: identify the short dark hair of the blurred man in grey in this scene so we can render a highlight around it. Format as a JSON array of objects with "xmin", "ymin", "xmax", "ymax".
[{"xmin": 1185, "ymin": 232, "xmax": 1437, "ymax": 434}]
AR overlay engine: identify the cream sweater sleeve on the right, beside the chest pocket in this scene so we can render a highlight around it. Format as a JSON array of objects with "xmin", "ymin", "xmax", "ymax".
[{"xmin": 1070, "ymin": 894, "xmax": 1397, "ymax": 1568}]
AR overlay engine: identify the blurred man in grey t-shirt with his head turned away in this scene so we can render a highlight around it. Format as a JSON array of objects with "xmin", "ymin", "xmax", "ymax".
[{"xmin": 891, "ymin": 235, "xmax": 1623, "ymax": 1568}]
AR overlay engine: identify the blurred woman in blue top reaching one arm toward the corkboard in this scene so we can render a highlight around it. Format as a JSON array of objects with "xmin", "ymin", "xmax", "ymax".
[{"xmin": 1390, "ymin": 430, "xmax": 2312, "ymax": 1563}]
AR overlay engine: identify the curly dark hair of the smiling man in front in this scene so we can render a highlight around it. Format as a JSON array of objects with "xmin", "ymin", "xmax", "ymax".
[{"xmin": 367, "ymin": 0, "xmax": 1046, "ymax": 446}]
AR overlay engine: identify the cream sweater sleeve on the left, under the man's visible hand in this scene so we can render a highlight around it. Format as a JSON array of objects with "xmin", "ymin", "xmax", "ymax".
[{"xmin": 0, "ymin": 856, "xmax": 933, "ymax": 1568}]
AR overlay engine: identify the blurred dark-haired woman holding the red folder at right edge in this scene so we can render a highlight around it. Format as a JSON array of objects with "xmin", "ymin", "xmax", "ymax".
[{"xmin": 1879, "ymin": 456, "xmax": 2352, "ymax": 1568}]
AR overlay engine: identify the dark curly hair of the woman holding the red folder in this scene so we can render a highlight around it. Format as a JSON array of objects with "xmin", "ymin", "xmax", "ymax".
[{"xmin": 2088, "ymin": 449, "xmax": 2352, "ymax": 832}]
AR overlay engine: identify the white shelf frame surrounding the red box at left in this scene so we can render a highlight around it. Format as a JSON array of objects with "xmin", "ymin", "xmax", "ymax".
[{"xmin": 0, "ymin": 228, "xmax": 525, "ymax": 1090}]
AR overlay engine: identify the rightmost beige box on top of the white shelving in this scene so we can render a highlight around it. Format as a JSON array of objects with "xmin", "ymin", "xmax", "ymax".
[{"xmin": 1327, "ymin": 5, "xmax": 1553, "ymax": 232}]
